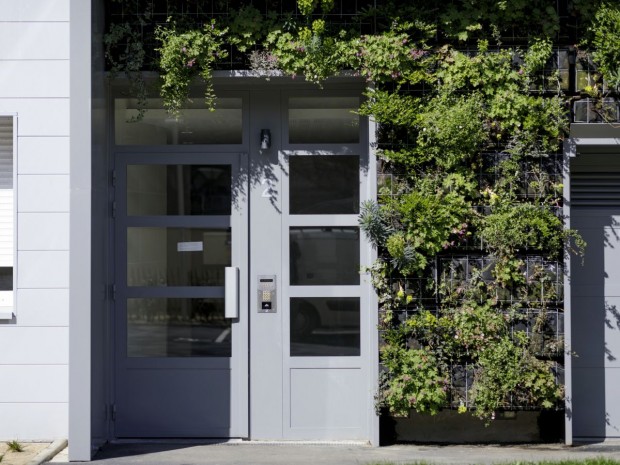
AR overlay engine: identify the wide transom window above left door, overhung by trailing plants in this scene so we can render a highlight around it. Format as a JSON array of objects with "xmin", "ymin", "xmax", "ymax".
[{"xmin": 114, "ymin": 98, "xmax": 243, "ymax": 145}]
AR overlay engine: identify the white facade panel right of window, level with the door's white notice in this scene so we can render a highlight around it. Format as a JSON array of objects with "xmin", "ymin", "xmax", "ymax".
[{"xmin": 17, "ymin": 213, "xmax": 69, "ymax": 250}]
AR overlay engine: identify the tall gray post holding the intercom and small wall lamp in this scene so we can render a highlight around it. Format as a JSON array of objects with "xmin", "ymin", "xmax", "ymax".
[{"xmin": 248, "ymin": 89, "xmax": 283, "ymax": 439}]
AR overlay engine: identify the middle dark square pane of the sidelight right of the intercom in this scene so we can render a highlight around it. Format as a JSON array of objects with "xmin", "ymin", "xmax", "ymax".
[{"xmin": 290, "ymin": 227, "xmax": 360, "ymax": 286}]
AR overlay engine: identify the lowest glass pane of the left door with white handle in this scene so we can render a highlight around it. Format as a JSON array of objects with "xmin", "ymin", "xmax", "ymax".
[{"xmin": 127, "ymin": 299, "xmax": 231, "ymax": 357}]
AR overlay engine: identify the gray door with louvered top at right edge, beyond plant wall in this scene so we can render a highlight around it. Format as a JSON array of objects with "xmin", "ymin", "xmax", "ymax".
[{"xmin": 568, "ymin": 165, "xmax": 620, "ymax": 440}]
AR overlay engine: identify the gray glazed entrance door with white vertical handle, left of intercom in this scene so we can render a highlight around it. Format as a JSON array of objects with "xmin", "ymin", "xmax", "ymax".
[{"xmin": 114, "ymin": 153, "xmax": 248, "ymax": 438}]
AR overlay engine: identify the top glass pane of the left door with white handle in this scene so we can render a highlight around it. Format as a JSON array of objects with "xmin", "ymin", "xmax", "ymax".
[{"xmin": 127, "ymin": 165, "xmax": 232, "ymax": 216}]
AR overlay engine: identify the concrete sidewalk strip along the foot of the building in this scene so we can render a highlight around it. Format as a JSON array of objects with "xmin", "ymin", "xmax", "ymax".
[{"xmin": 49, "ymin": 442, "xmax": 620, "ymax": 465}]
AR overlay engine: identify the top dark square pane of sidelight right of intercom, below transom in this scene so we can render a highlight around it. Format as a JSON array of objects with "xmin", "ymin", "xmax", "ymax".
[{"xmin": 289, "ymin": 155, "xmax": 360, "ymax": 215}]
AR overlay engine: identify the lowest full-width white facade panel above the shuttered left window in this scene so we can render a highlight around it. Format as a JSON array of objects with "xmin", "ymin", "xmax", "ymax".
[{"xmin": 0, "ymin": 60, "xmax": 69, "ymax": 98}]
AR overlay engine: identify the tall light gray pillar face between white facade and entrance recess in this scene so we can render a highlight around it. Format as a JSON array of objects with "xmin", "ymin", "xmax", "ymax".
[{"xmin": 68, "ymin": 0, "xmax": 92, "ymax": 461}]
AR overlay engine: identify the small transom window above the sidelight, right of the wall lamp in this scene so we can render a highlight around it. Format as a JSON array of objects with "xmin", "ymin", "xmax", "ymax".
[{"xmin": 288, "ymin": 97, "xmax": 360, "ymax": 144}]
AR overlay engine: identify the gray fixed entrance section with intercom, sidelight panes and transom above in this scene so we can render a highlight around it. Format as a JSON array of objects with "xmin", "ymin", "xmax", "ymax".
[{"xmin": 250, "ymin": 89, "xmax": 378, "ymax": 441}]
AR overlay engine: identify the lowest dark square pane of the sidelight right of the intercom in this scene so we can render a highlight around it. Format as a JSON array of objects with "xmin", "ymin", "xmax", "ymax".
[{"xmin": 291, "ymin": 297, "xmax": 360, "ymax": 356}]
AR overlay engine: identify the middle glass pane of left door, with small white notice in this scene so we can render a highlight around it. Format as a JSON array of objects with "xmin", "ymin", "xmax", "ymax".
[{"xmin": 127, "ymin": 227, "xmax": 231, "ymax": 287}]
